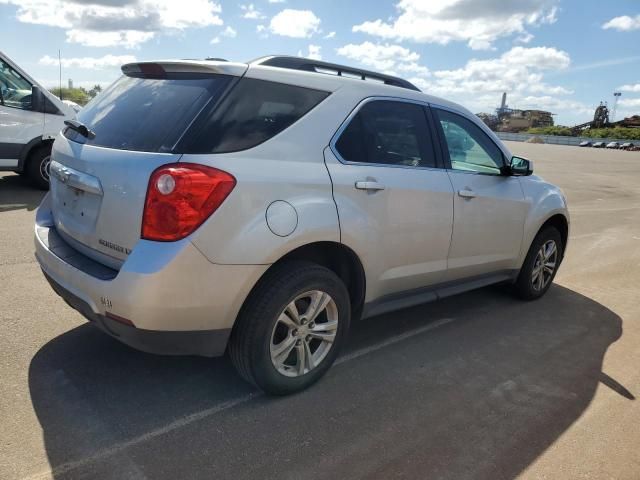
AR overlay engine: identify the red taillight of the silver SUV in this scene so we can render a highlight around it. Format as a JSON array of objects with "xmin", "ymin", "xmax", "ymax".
[{"xmin": 142, "ymin": 163, "xmax": 236, "ymax": 242}]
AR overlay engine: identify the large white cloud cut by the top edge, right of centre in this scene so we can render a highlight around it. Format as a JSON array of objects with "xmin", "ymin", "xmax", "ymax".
[{"xmin": 353, "ymin": 0, "xmax": 557, "ymax": 50}]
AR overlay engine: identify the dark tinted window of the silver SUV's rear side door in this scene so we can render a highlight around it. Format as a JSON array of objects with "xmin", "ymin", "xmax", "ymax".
[{"xmin": 336, "ymin": 100, "xmax": 436, "ymax": 167}]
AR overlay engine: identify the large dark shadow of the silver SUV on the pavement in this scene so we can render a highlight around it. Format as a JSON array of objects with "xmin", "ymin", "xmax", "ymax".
[{"xmin": 29, "ymin": 286, "xmax": 624, "ymax": 479}]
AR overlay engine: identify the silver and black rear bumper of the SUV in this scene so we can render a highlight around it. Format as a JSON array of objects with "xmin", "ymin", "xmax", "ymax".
[{"xmin": 35, "ymin": 195, "xmax": 268, "ymax": 356}]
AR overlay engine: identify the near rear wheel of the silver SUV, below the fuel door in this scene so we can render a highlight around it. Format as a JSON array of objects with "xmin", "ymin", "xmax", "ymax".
[{"xmin": 229, "ymin": 261, "xmax": 351, "ymax": 395}]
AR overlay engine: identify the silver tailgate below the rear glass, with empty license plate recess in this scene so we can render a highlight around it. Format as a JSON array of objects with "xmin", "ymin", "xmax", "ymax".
[{"xmin": 51, "ymin": 135, "xmax": 181, "ymax": 269}]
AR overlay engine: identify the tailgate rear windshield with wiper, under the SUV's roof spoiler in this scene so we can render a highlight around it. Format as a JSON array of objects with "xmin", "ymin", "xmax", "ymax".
[{"xmin": 65, "ymin": 73, "xmax": 231, "ymax": 152}]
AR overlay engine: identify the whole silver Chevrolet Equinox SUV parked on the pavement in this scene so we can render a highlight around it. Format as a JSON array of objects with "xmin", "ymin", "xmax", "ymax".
[{"xmin": 35, "ymin": 56, "xmax": 569, "ymax": 394}]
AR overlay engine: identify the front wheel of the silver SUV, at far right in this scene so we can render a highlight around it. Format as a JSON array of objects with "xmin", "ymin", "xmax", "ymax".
[{"xmin": 515, "ymin": 226, "xmax": 564, "ymax": 300}]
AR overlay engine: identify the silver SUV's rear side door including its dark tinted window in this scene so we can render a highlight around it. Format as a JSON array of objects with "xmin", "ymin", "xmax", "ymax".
[{"xmin": 325, "ymin": 98, "xmax": 453, "ymax": 301}]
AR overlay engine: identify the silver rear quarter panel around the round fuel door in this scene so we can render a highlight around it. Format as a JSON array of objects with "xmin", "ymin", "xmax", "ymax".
[{"xmin": 183, "ymin": 151, "xmax": 340, "ymax": 265}]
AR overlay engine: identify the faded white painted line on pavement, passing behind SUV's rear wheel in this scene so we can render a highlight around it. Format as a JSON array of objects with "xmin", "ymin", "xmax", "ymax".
[{"xmin": 23, "ymin": 318, "xmax": 453, "ymax": 480}]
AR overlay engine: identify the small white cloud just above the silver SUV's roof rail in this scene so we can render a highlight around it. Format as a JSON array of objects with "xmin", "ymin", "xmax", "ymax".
[{"xmin": 336, "ymin": 42, "xmax": 429, "ymax": 76}]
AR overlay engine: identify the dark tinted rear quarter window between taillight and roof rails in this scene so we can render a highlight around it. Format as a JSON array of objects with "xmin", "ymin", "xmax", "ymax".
[{"xmin": 179, "ymin": 78, "xmax": 329, "ymax": 153}]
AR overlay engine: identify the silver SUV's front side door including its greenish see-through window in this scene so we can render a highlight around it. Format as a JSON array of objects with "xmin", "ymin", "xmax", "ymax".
[{"xmin": 431, "ymin": 107, "xmax": 528, "ymax": 280}]
